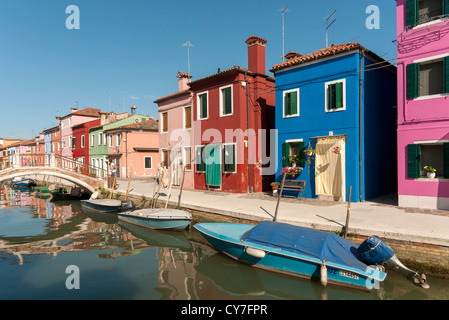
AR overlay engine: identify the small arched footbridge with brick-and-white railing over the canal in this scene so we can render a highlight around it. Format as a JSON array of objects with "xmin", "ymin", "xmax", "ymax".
[{"xmin": 0, "ymin": 155, "xmax": 108, "ymax": 193}]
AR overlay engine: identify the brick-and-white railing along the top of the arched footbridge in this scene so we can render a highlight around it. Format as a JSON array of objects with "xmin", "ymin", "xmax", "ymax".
[{"xmin": 0, "ymin": 154, "xmax": 109, "ymax": 180}]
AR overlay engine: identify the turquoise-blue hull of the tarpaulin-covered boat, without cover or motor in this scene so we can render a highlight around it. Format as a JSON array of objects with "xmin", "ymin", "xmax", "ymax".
[{"xmin": 194, "ymin": 223, "xmax": 385, "ymax": 291}]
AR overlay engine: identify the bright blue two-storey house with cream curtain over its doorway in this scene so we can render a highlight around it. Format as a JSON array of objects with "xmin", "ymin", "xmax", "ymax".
[{"xmin": 271, "ymin": 43, "xmax": 397, "ymax": 202}]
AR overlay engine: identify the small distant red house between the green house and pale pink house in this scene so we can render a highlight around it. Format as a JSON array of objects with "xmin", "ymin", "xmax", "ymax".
[{"xmin": 72, "ymin": 119, "xmax": 101, "ymax": 171}]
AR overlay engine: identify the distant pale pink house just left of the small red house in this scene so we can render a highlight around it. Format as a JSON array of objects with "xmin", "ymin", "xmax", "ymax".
[{"xmin": 56, "ymin": 108, "xmax": 101, "ymax": 159}]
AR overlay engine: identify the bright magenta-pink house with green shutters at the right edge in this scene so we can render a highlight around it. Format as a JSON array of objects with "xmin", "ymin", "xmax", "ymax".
[{"xmin": 397, "ymin": 0, "xmax": 449, "ymax": 209}]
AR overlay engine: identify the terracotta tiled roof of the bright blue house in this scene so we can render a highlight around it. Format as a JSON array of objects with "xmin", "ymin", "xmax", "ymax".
[{"xmin": 271, "ymin": 42, "xmax": 370, "ymax": 72}]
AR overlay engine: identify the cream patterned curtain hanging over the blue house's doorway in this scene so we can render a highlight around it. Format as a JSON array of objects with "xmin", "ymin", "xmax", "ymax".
[{"xmin": 315, "ymin": 136, "xmax": 346, "ymax": 197}]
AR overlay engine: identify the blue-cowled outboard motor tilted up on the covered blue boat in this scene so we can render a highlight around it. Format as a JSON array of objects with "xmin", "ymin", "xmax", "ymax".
[{"xmin": 357, "ymin": 236, "xmax": 430, "ymax": 289}]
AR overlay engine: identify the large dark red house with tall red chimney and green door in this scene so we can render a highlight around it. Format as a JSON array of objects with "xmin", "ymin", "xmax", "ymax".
[{"xmin": 189, "ymin": 36, "xmax": 275, "ymax": 193}]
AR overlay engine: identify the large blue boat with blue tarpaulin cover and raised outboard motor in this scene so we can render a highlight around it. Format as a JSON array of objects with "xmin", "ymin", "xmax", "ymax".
[{"xmin": 194, "ymin": 221, "xmax": 426, "ymax": 291}]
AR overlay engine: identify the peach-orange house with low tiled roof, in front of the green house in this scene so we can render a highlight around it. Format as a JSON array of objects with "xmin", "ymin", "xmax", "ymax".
[{"xmin": 104, "ymin": 117, "xmax": 159, "ymax": 178}]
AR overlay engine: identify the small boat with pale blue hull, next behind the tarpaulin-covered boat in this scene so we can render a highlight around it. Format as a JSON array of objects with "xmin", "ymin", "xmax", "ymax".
[{"xmin": 118, "ymin": 209, "xmax": 192, "ymax": 230}]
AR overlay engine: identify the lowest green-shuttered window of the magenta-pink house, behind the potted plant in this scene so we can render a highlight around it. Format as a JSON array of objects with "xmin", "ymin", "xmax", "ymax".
[{"xmin": 407, "ymin": 142, "xmax": 449, "ymax": 179}]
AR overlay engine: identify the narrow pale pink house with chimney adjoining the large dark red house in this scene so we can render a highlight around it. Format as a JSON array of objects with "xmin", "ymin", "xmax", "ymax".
[{"xmin": 155, "ymin": 72, "xmax": 194, "ymax": 189}]
